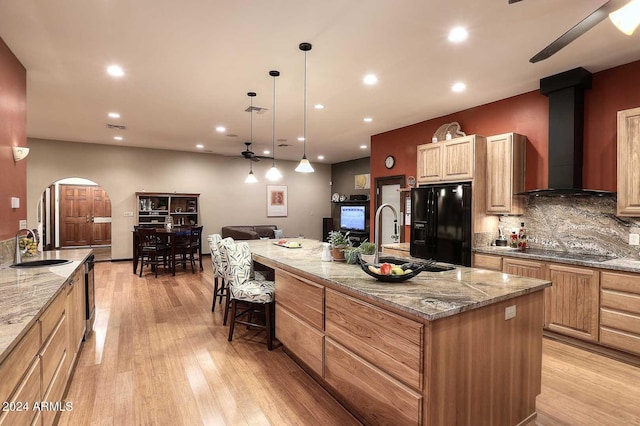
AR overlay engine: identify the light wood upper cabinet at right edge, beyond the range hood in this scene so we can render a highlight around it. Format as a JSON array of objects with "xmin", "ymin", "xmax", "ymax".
[{"xmin": 618, "ymin": 108, "xmax": 640, "ymax": 216}]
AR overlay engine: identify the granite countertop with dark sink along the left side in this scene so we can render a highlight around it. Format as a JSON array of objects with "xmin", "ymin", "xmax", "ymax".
[{"xmin": 0, "ymin": 249, "xmax": 92, "ymax": 362}]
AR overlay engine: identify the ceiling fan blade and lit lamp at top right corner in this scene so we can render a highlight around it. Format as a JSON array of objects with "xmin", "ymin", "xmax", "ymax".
[{"xmin": 509, "ymin": 0, "xmax": 640, "ymax": 64}]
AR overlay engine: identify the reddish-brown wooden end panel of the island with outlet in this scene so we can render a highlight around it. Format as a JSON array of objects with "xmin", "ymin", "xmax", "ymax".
[{"xmin": 424, "ymin": 291, "xmax": 543, "ymax": 426}]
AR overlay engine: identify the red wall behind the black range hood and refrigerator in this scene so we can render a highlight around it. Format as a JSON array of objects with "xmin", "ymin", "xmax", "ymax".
[{"xmin": 370, "ymin": 61, "xmax": 640, "ymax": 241}]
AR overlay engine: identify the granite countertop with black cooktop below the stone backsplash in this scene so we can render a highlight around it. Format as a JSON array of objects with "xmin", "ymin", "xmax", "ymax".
[{"xmin": 473, "ymin": 246, "xmax": 640, "ymax": 273}]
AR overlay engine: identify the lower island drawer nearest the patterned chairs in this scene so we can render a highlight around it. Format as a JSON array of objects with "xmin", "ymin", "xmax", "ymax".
[{"xmin": 276, "ymin": 305, "xmax": 324, "ymax": 377}]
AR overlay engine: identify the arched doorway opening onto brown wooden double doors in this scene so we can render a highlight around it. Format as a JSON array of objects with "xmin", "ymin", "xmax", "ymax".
[{"xmin": 38, "ymin": 177, "xmax": 111, "ymax": 261}]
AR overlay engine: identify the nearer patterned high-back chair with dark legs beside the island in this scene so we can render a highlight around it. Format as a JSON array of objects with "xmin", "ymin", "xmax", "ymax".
[{"xmin": 218, "ymin": 240, "xmax": 275, "ymax": 350}]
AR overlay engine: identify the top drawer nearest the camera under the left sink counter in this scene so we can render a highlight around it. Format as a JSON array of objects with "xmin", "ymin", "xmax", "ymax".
[{"xmin": 0, "ymin": 322, "xmax": 40, "ymax": 402}]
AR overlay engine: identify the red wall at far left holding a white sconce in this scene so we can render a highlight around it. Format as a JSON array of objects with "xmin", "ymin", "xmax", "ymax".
[{"xmin": 0, "ymin": 38, "xmax": 28, "ymax": 241}]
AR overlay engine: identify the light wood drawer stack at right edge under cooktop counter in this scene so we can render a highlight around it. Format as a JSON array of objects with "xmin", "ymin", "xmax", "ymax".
[{"xmin": 600, "ymin": 272, "xmax": 640, "ymax": 354}]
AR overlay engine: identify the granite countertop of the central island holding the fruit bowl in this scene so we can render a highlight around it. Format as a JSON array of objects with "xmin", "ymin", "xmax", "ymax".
[{"xmin": 249, "ymin": 238, "xmax": 551, "ymax": 321}]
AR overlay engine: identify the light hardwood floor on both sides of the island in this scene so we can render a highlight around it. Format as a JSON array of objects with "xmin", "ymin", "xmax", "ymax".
[{"xmin": 60, "ymin": 259, "xmax": 640, "ymax": 426}]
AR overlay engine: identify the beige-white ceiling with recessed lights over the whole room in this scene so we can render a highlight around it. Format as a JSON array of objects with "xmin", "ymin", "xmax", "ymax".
[{"xmin": 0, "ymin": 0, "xmax": 640, "ymax": 163}]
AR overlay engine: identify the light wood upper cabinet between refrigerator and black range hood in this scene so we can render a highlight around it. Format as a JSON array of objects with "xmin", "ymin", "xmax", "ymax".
[{"xmin": 486, "ymin": 133, "xmax": 527, "ymax": 214}]
